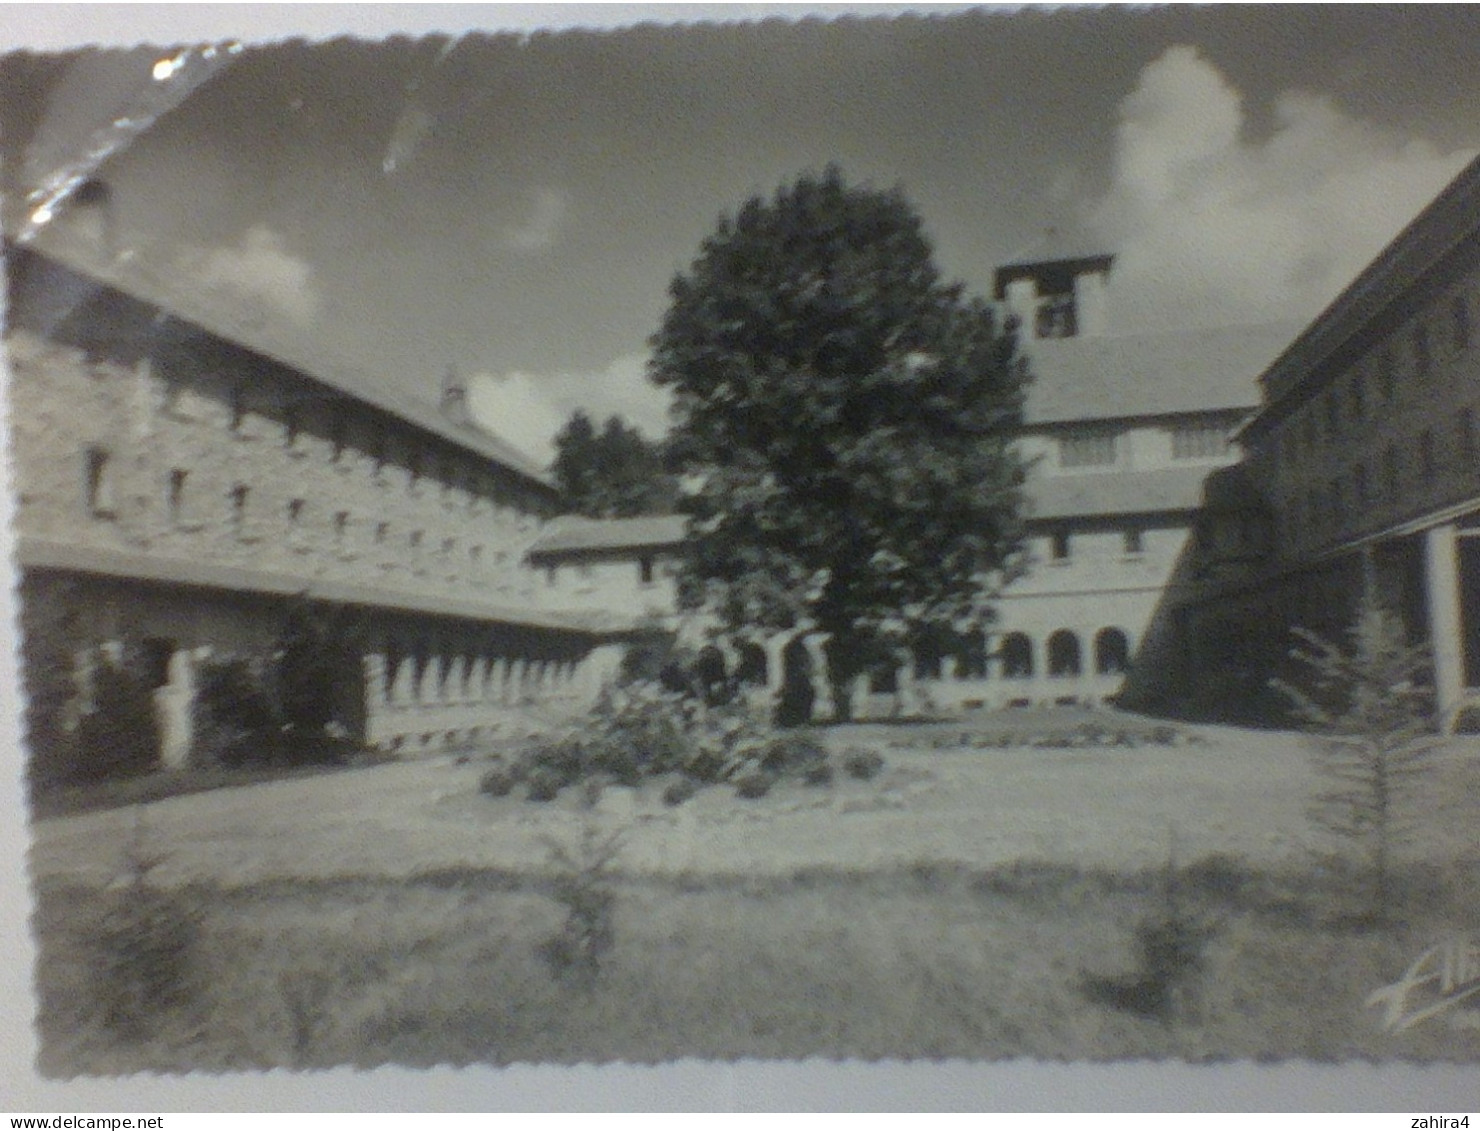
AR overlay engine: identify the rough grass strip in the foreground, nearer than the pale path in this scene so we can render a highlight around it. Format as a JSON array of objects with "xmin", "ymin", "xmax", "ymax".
[{"xmin": 36, "ymin": 862, "xmax": 1480, "ymax": 1075}]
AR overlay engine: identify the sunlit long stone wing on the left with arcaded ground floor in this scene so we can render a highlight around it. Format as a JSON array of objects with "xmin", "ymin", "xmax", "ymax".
[{"xmin": 6, "ymin": 234, "xmax": 629, "ymax": 777}]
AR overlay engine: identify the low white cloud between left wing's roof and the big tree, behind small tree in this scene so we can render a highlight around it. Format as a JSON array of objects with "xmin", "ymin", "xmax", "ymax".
[{"xmin": 468, "ymin": 354, "xmax": 669, "ymax": 462}]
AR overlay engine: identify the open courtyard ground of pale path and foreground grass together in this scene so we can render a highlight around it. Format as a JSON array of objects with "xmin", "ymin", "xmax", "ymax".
[{"xmin": 20, "ymin": 718, "xmax": 1480, "ymax": 1075}]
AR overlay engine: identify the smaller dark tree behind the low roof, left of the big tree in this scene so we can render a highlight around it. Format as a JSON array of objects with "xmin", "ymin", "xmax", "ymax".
[{"xmin": 552, "ymin": 410, "xmax": 676, "ymax": 518}]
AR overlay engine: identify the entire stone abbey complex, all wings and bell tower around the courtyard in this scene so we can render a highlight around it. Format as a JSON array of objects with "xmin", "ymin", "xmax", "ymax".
[{"xmin": 17, "ymin": 145, "xmax": 1480, "ymax": 770}]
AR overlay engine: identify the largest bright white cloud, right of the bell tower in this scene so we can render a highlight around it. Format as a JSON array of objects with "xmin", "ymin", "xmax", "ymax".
[{"xmin": 1089, "ymin": 46, "xmax": 1474, "ymax": 330}]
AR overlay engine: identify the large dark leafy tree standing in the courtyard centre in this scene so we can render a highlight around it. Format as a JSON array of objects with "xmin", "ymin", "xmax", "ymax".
[{"xmin": 650, "ymin": 167, "xmax": 1027, "ymax": 709}]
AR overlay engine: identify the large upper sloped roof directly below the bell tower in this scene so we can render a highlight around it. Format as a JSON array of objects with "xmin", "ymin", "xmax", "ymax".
[{"xmin": 1023, "ymin": 323, "xmax": 1299, "ymax": 426}]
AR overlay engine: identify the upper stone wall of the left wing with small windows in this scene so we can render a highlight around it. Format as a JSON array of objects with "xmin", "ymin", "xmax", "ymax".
[{"xmin": 7, "ymin": 332, "xmax": 549, "ymax": 607}]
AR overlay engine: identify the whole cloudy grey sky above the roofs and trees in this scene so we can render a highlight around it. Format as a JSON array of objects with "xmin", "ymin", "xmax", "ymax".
[{"xmin": 0, "ymin": 6, "xmax": 1480, "ymax": 459}]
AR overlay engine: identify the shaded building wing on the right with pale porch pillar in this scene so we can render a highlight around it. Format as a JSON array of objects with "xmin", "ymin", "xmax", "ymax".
[{"xmin": 1168, "ymin": 150, "xmax": 1480, "ymax": 727}]
